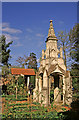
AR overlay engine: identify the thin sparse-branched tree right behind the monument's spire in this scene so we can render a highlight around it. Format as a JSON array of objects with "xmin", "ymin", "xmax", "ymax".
[{"xmin": 58, "ymin": 31, "xmax": 70, "ymax": 68}]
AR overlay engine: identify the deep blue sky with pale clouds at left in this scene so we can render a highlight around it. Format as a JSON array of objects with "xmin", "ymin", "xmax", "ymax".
[{"xmin": 2, "ymin": 2, "xmax": 77, "ymax": 64}]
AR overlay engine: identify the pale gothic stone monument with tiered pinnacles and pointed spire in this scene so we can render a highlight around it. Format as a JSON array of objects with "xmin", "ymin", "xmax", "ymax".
[{"xmin": 33, "ymin": 20, "xmax": 72, "ymax": 106}]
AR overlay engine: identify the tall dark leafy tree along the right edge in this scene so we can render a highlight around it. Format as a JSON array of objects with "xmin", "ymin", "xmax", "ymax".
[{"xmin": 69, "ymin": 24, "xmax": 79, "ymax": 98}]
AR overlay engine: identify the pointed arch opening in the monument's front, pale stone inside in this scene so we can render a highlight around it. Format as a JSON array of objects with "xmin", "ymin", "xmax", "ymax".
[{"xmin": 50, "ymin": 72, "xmax": 63, "ymax": 103}]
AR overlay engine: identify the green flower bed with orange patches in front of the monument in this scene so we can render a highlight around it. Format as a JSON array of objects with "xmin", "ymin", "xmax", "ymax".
[{"xmin": 2, "ymin": 96, "xmax": 72, "ymax": 120}]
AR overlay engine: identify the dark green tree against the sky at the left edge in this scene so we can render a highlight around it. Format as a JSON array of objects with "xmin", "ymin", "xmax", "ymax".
[{"xmin": 0, "ymin": 35, "xmax": 13, "ymax": 66}]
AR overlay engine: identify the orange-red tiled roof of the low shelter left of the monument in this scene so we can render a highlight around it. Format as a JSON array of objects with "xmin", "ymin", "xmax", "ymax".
[{"xmin": 11, "ymin": 68, "xmax": 35, "ymax": 75}]
